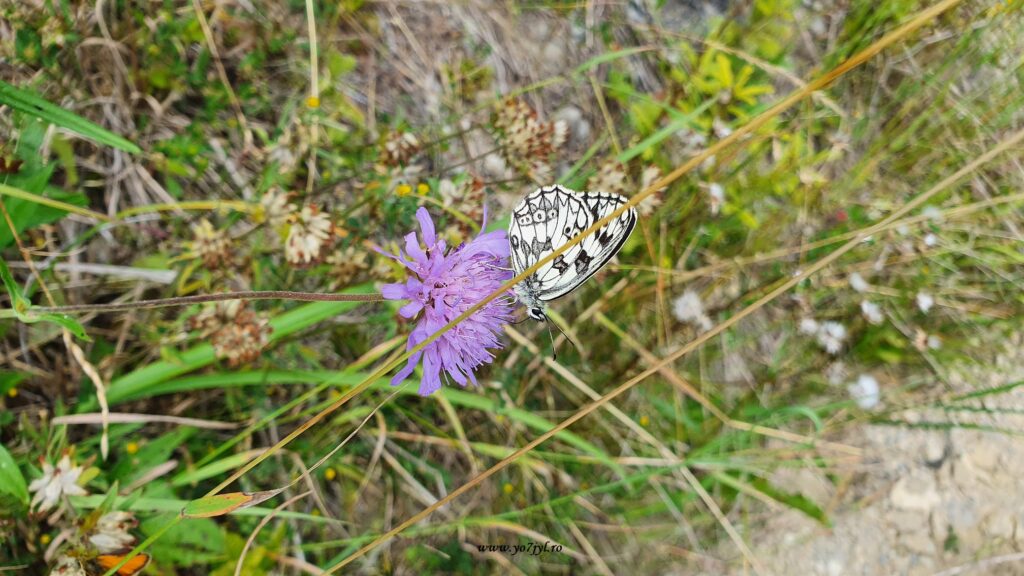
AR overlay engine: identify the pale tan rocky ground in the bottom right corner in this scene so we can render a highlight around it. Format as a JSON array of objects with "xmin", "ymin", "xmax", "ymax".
[{"xmin": 735, "ymin": 336, "xmax": 1024, "ymax": 576}]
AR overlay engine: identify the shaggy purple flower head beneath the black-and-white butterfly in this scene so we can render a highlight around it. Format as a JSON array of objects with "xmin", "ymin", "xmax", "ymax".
[{"xmin": 381, "ymin": 208, "xmax": 514, "ymax": 396}]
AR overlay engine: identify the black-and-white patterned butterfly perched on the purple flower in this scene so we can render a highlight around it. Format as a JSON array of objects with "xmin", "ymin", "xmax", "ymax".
[{"xmin": 509, "ymin": 184, "xmax": 637, "ymax": 321}]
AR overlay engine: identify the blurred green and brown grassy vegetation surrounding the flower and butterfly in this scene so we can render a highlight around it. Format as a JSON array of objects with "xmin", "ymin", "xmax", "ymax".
[{"xmin": 0, "ymin": 0, "xmax": 1024, "ymax": 575}]
